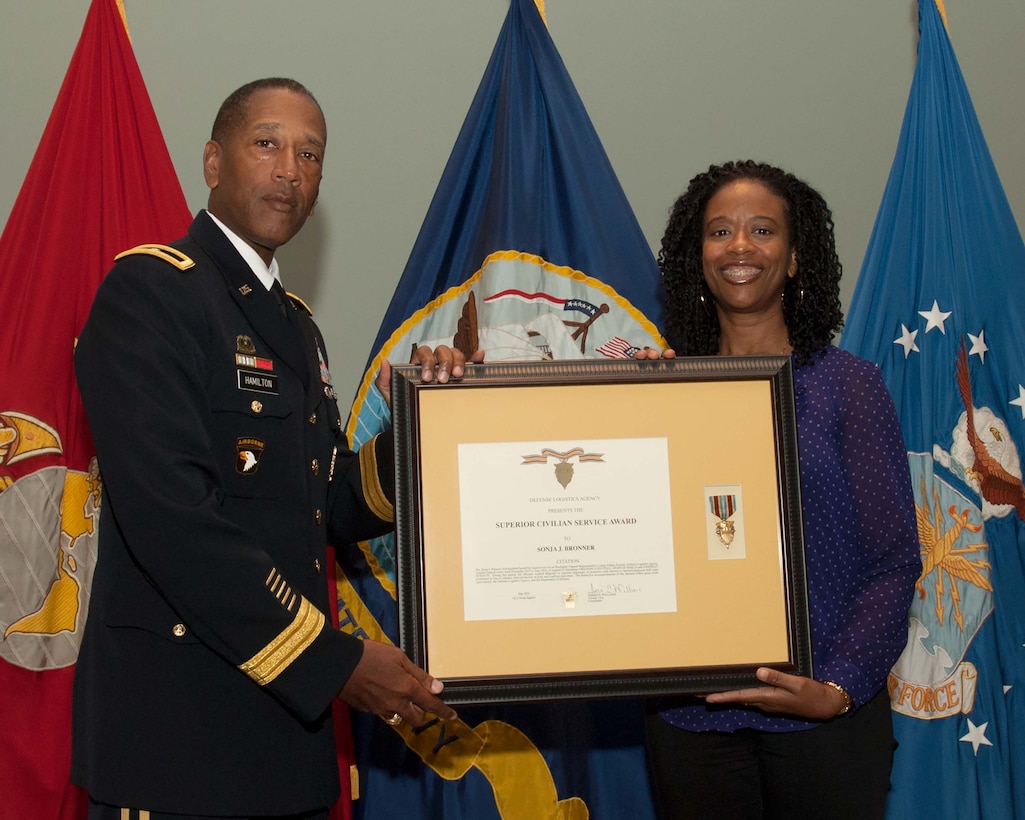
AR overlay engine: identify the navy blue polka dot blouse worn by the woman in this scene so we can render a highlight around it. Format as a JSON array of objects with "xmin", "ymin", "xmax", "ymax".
[{"xmin": 659, "ymin": 347, "xmax": 921, "ymax": 732}]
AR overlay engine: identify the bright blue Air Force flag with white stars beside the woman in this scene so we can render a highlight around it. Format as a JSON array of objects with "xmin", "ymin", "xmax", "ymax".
[{"xmin": 842, "ymin": 0, "xmax": 1025, "ymax": 820}]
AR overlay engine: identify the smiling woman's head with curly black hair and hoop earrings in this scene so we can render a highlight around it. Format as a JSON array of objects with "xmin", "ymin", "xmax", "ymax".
[{"xmin": 659, "ymin": 160, "xmax": 844, "ymax": 365}]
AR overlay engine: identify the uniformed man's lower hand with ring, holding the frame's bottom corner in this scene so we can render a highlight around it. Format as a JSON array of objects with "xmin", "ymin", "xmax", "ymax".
[{"xmin": 338, "ymin": 640, "xmax": 455, "ymax": 726}]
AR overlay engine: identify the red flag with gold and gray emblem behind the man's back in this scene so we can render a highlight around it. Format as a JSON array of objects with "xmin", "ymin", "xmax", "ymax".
[{"xmin": 0, "ymin": 0, "xmax": 191, "ymax": 820}]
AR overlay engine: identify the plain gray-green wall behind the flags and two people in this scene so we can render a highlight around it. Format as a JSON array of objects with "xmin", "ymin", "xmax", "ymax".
[{"xmin": 0, "ymin": 0, "xmax": 1025, "ymax": 404}]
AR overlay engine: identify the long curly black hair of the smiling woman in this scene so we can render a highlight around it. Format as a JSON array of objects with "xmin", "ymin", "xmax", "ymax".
[{"xmin": 658, "ymin": 160, "xmax": 844, "ymax": 366}]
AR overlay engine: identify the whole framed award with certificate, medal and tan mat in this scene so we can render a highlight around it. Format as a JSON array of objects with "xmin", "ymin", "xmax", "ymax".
[{"xmin": 393, "ymin": 357, "xmax": 812, "ymax": 704}]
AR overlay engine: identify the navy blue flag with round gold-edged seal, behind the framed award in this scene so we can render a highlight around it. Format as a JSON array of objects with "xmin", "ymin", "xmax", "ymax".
[{"xmin": 338, "ymin": 0, "xmax": 664, "ymax": 820}]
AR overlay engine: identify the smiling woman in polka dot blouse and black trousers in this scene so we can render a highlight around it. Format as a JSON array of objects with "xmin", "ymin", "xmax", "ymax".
[{"xmin": 648, "ymin": 161, "xmax": 919, "ymax": 820}]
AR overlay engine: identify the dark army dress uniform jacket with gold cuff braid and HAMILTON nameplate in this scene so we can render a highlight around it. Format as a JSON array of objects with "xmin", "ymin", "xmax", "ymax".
[{"xmin": 72, "ymin": 212, "xmax": 394, "ymax": 815}]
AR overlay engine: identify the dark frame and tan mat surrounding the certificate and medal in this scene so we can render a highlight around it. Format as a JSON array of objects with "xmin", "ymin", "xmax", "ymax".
[{"xmin": 392, "ymin": 356, "xmax": 812, "ymax": 705}]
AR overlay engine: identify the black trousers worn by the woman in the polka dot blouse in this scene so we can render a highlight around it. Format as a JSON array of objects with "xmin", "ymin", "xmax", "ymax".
[{"xmin": 647, "ymin": 690, "xmax": 897, "ymax": 820}]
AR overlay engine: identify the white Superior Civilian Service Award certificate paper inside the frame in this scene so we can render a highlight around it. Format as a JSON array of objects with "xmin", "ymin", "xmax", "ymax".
[{"xmin": 458, "ymin": 438, "xmax": 677, "ymax": 621}]
